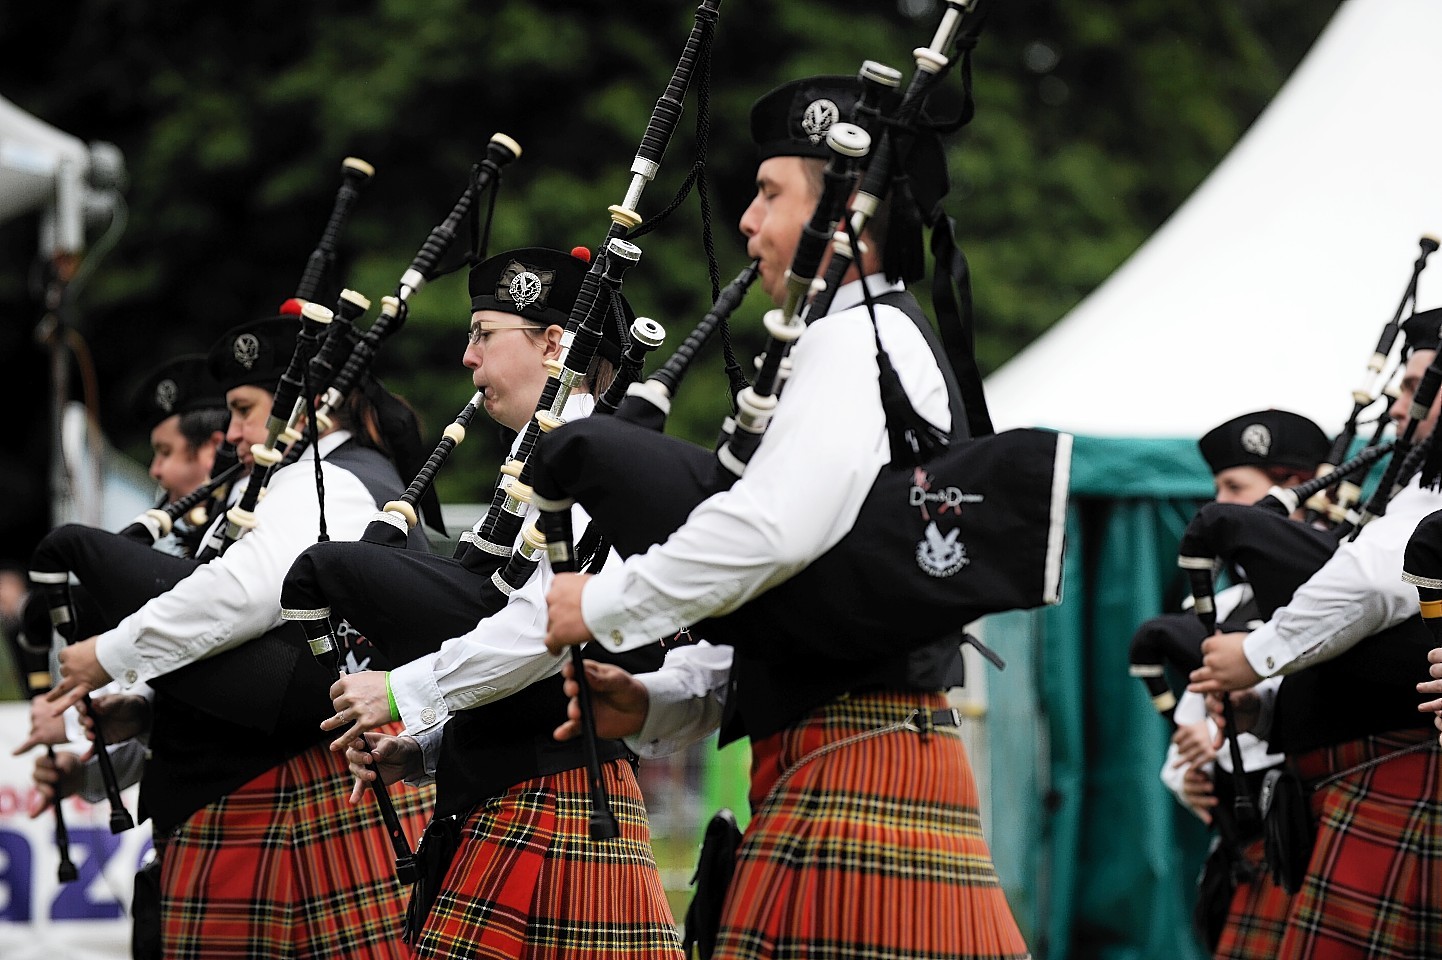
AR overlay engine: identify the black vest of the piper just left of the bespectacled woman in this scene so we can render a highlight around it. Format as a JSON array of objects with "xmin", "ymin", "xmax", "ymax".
[{"xmin": 140, "ymin": 441, "xmax": 430, "ymax": 832}]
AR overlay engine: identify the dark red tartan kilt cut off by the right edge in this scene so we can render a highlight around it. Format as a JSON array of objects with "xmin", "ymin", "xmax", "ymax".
[{"xmin": 1279, "ymin": 729, "xmax": 1442, "ymax": 960}]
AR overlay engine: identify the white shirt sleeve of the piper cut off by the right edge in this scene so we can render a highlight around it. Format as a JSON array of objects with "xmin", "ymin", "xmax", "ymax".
[{"xmin": 1242, "ymin": 481, "xmax": 1442, "ymax": 676}]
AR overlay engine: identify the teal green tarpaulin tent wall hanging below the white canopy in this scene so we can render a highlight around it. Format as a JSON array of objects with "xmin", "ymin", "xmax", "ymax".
[{"xmin": 983, "ymin": 437, "xmax": 1213, "ymax": 960}]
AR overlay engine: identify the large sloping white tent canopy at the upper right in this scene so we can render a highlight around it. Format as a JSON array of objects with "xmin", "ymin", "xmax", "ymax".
[{"xmin": 981, "ymin": 0, "xmax": 1442, "ymax": 438}]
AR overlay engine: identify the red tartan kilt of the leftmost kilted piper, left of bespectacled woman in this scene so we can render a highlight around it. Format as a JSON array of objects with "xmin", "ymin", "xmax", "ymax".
[{"xmin": 160, "ymin": 724, "xmax": 434, "ymax": 960}]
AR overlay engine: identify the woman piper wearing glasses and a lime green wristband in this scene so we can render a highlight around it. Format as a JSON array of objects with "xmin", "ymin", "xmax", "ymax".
[{"xmin": 323, "ymin": 248, "xmax": 682, "ymax": 960}]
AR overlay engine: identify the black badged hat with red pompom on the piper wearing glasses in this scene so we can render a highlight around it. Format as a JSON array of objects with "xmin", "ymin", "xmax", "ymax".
[{"xmin": 470, "ymin": 246, "xmax": 636, "ymax": 363}]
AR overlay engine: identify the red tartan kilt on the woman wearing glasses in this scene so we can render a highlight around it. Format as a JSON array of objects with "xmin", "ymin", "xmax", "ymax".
[{"xmin": 415, "ymin": 760, "xmax": 682, "ymax": 960}]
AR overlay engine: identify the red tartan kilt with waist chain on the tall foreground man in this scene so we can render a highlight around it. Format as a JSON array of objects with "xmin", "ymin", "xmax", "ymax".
[{"xmin": 712, "ymin": 692, "xmax": 1030, "ymax": 960}]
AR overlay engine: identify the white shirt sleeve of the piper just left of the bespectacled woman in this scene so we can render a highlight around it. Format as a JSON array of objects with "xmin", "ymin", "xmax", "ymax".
[{"xmin": 95, "ymin": 430, "xmax": 375, "ymax": 690}]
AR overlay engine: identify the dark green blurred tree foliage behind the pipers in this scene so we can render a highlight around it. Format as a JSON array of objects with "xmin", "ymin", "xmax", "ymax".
[{"xmin": 0, "ymin": 0, "xmax": 1337, "ymax": 500}]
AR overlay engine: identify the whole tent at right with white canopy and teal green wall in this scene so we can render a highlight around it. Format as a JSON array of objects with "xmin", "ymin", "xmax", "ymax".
[{"xmin": 986, "ymin": 0, "xmax": 1442, "ymax": 959}]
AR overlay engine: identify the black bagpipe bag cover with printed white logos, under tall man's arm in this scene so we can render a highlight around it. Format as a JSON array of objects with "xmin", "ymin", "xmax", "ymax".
[{"xmin": 532, "ymin": 417, "xmax": 1071, "ymax": 660}]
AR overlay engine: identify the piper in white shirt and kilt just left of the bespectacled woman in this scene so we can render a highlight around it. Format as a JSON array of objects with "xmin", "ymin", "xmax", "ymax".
[{"xmin": 53, "ymin": 309, "xmax": 423, "ymax": 960}]
